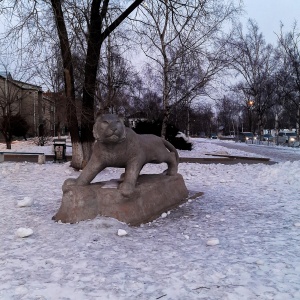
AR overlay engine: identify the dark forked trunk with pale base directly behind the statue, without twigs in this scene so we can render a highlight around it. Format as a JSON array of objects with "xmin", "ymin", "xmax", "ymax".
[{"xmin": 51, "ymin": 0, "xmax": 143, "ymax": 169}]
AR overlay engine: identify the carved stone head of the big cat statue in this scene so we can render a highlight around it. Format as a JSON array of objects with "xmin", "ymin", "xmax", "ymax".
[{"xmin": 93, "ymin": 114, "xmax": 126, "ymax": 144}]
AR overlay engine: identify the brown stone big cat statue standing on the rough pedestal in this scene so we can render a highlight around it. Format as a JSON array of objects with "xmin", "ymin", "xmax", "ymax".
[{"xmin": 63, "ymin": 114, "xmax": 179, "ymax": 196}]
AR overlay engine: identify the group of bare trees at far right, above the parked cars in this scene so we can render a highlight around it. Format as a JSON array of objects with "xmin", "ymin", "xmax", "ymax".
[{"xmin": 216, "ymin": 20, "xmax": 300, "ymax": 137}]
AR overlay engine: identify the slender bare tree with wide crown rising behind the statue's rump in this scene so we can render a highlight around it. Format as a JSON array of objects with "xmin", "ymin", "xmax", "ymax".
[{"xmin": 135, "ymin": 0, "xmax": 238, "ymax": 137}]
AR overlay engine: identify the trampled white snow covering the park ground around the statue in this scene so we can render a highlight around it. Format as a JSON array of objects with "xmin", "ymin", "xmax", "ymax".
[{"xmin": 0, "ymin": 139, "xmax": 300, "ymax": 300}]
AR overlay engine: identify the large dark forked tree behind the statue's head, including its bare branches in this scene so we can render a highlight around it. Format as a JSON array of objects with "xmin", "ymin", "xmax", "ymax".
[{"xmin": 0, "ymin": 0, "xmax": 143, "ymax": 168}]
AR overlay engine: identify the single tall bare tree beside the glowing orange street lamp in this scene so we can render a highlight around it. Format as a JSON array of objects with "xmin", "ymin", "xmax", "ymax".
[{"xmin": 228, "ymin": 20, "xmax": 276, "ymax": 137}]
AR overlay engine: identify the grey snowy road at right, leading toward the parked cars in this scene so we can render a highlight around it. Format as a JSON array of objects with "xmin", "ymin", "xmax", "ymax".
[{"xmin": 217, "ymin": 141, "xmax": 300, "ymax": 162}]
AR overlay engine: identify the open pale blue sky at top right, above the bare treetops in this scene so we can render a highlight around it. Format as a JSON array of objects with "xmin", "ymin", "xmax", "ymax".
[{"xmin": 241, "ymin": 0, "xmax": 300, "ymax": 44}]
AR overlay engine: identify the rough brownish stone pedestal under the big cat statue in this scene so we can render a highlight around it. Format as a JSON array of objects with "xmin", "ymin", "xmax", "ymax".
[{"xmin": 53, "ymin": 174, "xmax": 188, "ymax": 226}]
